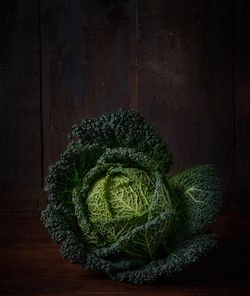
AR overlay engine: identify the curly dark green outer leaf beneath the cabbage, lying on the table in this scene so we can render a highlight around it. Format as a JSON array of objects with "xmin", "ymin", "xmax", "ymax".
[{"xmin": 84, "ymin": 234, "xmax": 216, "ymax": 284}]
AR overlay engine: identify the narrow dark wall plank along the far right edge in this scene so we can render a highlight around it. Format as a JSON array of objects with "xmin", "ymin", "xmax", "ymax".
[{"xmin": 233, "ymin": 0, "xmax": 250, "ymax": 209}]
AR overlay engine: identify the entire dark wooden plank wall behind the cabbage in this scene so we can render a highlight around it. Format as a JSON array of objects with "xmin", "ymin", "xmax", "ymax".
[{"xmin": 0, "ymin": 0, "xmax": 250, "ymax": 214}]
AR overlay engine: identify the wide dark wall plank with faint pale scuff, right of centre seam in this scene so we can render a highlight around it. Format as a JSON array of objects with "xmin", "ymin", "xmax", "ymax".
[{"xmin": 138, "ymin": 0, "xmax": 234, "ymax": 209}]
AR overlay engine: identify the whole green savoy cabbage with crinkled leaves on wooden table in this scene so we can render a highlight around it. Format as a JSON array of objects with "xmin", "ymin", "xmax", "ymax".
[{"xmin": 42, "ymin": 110, "xmax": 221, "ymax": 284}]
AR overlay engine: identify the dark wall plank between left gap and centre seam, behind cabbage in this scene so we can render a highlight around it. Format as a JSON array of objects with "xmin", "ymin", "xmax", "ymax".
[{"xmin": 41, "ymin": 0, "xmax": 136, "ymax": 208}]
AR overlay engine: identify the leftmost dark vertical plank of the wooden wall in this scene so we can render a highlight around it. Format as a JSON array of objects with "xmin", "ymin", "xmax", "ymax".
[{"xmin": 0, "ymin": 0, "xmax": 42, "ymax": 210}]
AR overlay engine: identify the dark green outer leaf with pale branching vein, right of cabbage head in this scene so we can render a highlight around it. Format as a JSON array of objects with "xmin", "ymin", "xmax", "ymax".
[{"xmin": 168, "ymin": 165, "xmax": 221, "ymax": 245}]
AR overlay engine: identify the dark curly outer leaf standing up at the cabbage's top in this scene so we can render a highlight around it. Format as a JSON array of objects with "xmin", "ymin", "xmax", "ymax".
[{"xmin": 73, "ymin": 110, "xmax": 172, "ymax": 173}]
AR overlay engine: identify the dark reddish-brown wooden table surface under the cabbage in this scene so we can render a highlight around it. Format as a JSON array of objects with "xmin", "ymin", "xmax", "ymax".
[{"xmin": 0, "ymin": 212, "xmax": 250, "ymax": 296}]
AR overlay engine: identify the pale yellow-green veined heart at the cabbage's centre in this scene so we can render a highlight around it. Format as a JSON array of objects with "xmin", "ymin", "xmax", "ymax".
[{"xmin": 86, "ymin": 168, "xmax": 154, "ymax": 222}]
